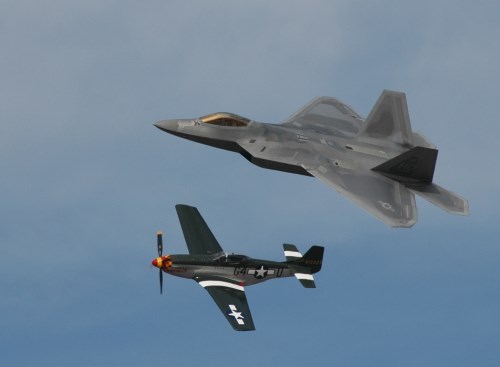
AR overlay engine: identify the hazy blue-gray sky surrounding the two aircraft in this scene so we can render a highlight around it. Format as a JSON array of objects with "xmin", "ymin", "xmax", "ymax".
[{"xmin": 0, "ymin": 0, "xmax": 500, "ymax": 366}]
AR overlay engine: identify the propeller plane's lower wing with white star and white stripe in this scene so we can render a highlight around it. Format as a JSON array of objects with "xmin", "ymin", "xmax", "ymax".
[{"xmin": 195, "ymin": 277, "xmax": 255, "ymax": 331}]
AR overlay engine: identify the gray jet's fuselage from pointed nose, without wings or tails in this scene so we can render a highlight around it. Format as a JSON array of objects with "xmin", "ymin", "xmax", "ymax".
[{"xmin": 155, "ymin": 119, "xmax": 402, "ymax": 176}]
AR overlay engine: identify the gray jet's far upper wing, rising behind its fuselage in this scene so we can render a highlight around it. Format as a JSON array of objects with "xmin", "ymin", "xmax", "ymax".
[{"xmin": 283, "ymin": 97, "xmax": 363, "ymax": 135}]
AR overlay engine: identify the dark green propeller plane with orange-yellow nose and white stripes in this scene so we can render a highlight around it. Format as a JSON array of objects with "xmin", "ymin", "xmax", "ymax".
[{"xmin": 152, "ymin": 205, "xmax": 324, "ymax": 331}]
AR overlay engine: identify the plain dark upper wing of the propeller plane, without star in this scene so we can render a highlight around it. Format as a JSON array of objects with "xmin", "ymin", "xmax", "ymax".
[{"xmin": 175, "ymin": 204, "xmax": 222, "ymax": 255}]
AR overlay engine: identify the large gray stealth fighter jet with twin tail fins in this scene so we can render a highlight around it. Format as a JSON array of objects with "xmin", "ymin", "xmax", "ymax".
[{"xmin": 155, "ymin": 90, "xmax": 469, "ymax": 227}]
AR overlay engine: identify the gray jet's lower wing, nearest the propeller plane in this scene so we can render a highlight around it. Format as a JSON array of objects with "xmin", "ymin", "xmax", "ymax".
[{"xmin": 303, "ymin": 164, "xmax": 417, "ymax": 227}]
